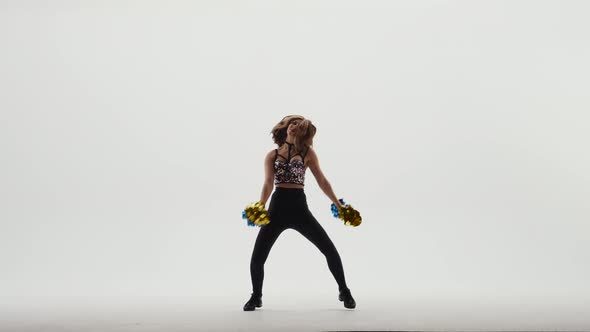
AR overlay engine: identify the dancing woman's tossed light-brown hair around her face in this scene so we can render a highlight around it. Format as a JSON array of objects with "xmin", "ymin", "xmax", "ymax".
[{"xmin": 271, "ymin": 115, "xmax": 317, "ymax": 153}]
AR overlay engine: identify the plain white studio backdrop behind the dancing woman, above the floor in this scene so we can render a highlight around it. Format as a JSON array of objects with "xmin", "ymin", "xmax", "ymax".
[{"xmin": 0, "ymin": 1, "xmax": 590, "ymax": 310}]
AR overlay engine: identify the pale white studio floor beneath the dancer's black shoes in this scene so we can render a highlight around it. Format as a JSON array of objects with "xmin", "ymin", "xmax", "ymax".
[{"xmin": 0, "ymin": 294, "xmax": 590, "ymax": 332}]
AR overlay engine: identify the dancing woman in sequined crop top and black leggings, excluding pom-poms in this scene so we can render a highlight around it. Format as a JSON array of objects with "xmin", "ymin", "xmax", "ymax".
[{"xmin": 244, "ymin": 115, "xmax": 356, "ymax": 311}]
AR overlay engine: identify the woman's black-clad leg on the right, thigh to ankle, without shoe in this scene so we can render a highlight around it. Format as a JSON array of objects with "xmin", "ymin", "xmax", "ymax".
[{"xmin": 292, "ymin": 212, "xmax": 348, "ymax": 290}]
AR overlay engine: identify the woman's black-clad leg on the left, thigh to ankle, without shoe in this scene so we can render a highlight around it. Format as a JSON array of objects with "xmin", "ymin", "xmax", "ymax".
[{"xmin": 250, "ymin": 218, "xmax": 286, "ymax": 296}]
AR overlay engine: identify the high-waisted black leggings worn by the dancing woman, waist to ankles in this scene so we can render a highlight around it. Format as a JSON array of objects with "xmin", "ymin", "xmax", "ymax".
[{"xmin": 250, "ymin": 187, "xmax": 347, "ymax": 296}]
